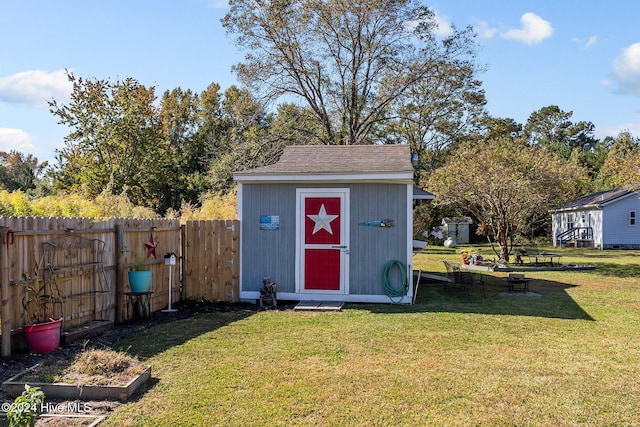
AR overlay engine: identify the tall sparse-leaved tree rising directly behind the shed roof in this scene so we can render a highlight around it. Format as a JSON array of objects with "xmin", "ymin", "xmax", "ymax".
[{"xmin": 223, "ymin": 0, "xmax": 476, "ymax": 144}]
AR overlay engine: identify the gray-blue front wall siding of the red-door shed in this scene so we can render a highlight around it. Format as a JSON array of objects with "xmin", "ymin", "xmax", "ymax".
[{"xmin": 241, "ymin": 183, "xmax": 409, "ymax": 295}]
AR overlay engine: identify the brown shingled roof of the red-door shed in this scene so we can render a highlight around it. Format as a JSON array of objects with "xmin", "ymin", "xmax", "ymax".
[{"xmin": 233, "ymin": 144, "xmax": 413, "ymax": 181}]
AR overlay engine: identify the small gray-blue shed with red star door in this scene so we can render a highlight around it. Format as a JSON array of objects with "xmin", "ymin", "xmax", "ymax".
[{"xmin": 234, "ymin": 145, "xmax": 413, "ymax": 303}]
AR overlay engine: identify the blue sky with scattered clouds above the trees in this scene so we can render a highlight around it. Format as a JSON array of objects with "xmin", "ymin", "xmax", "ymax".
[{"xmin": 0, "ymin": 0, "xmax": 640, "ymax": 162}]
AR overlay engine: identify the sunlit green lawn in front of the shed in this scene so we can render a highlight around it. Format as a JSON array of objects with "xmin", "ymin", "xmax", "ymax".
[{"xmin": 103, "ymin": 248, "xmax": 640, "ymax": 426}]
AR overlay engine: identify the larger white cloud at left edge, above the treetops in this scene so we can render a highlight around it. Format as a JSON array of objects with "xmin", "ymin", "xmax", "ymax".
[{"xmin": 0, "ymin": 70, "xmax": 73, "ymax": 108}]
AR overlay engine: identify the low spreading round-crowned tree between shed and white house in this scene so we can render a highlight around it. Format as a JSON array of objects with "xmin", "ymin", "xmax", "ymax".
[{"xmin": 429, "ymin": 137, "xmax": 587, "ymax": 261}]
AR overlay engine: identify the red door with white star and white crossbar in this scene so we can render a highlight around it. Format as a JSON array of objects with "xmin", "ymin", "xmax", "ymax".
[{"xmin": 300, "ymin": 190, "xmax": 348, "ymax": 293}]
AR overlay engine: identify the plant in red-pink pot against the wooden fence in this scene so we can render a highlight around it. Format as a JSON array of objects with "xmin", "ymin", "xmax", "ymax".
[{"xmin": 17, "ymin": 273, "xmax": 62, "ymax": 353}]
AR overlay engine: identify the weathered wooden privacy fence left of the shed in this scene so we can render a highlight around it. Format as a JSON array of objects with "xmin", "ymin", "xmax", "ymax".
[{"xmin": 0, "ymin": 217, "xmax": 239, "ymax": 356}]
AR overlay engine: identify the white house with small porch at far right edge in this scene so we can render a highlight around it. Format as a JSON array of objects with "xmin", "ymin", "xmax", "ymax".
[{"xmin": 551, "ymin": 189, "xmax": 640, "ymax": 249}]
